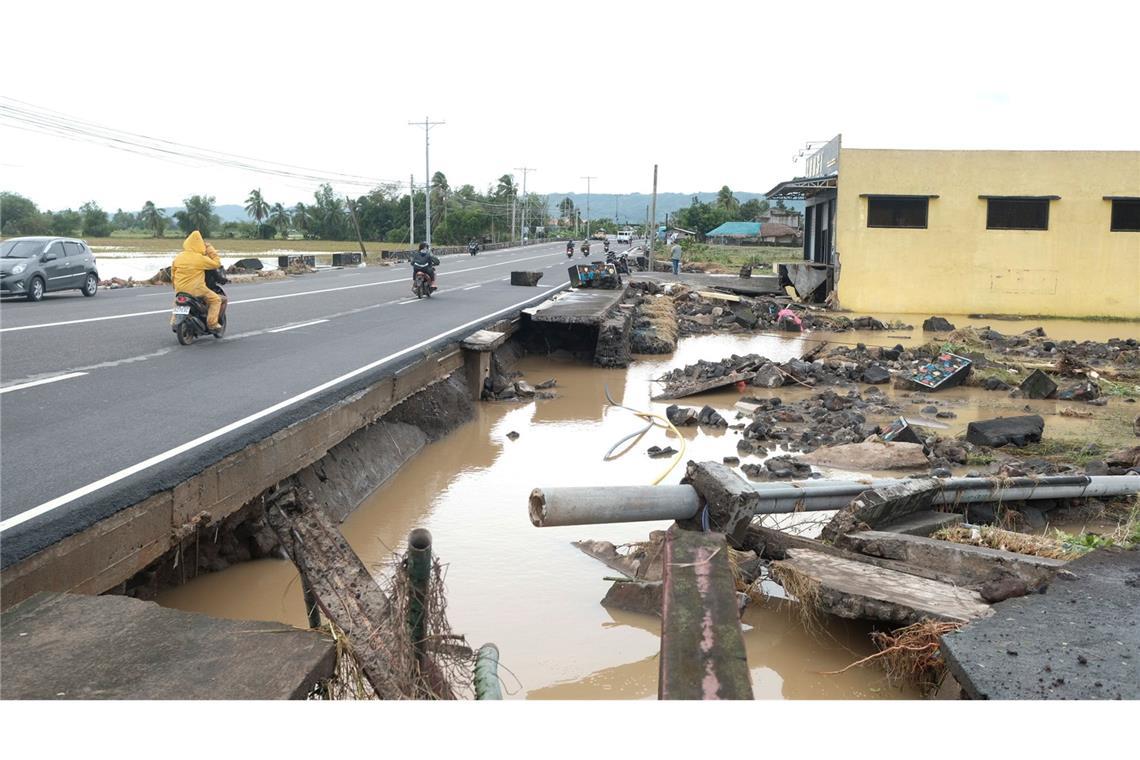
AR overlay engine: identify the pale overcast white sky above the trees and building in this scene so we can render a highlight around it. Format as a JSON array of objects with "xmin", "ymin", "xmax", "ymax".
[{"xmin": 0, "ymin": 0, "xmax": 1140, "ymax": 210}]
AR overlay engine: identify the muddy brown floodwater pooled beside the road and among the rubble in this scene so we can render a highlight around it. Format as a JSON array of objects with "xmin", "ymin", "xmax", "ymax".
[{"xmin": 158, "ymin": 314, "xmax": 1137, "ymax": 700}]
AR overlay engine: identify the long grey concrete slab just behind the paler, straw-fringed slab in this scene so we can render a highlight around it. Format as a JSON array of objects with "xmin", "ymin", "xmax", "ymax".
[{"xmin": 839, "ymin": 531, "xmax": 1065, "ymax": 590}]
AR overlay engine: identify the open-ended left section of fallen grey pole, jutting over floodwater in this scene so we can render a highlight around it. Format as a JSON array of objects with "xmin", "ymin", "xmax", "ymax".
[{"xmin": 530, "ymin": 485, "xmax": 701, "ymax": 528}]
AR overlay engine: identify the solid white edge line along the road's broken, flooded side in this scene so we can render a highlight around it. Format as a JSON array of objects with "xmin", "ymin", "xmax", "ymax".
[{"xmin": 0, "ymin": 283, "xmax": 569, "ymax": 533}]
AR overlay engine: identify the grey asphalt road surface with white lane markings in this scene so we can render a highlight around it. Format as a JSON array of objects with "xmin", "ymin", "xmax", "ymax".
[{"xmin": 0, "ymin": 243, "xmax": 601, "ymax": 567}]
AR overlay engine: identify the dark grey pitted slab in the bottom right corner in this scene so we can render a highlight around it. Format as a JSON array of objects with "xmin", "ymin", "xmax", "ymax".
[{"xmin": 942, "ymin": 549, "xmax": 1140, "ymax": 700}]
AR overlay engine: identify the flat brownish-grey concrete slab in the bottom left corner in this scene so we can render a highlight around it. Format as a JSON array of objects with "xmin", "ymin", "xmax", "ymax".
[{"xmin": 0, "ymin": 593, "xmax": 336, "ymax": 700}]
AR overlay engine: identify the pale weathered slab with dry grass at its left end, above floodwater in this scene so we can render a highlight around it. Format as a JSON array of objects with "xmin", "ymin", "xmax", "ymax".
[{"xmin": 772, "ymin": 549, "xmax": 993, "ymax": 627}]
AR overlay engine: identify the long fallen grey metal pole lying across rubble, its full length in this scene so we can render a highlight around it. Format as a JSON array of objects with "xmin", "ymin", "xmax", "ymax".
[{"xmin": 530, "ymin": 475, "xmax": 1140, "ymax": 528}]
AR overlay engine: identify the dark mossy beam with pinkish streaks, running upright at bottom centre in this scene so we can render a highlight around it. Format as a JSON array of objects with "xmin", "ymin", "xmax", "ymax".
[{"xmin": 658, "ymin": 525, "xmax": 752, "ymax": 700}]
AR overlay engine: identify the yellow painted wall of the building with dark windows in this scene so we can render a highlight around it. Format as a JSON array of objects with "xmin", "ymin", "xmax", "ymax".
[{"xmin": 836, "ymin": 149, "xmax": 1140, "ymax": 318}]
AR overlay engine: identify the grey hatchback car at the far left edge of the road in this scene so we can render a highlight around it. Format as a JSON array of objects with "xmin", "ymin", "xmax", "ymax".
[{"xmin": 0, "ymin": 236, "xmax": 99, "ymax": 301}]
